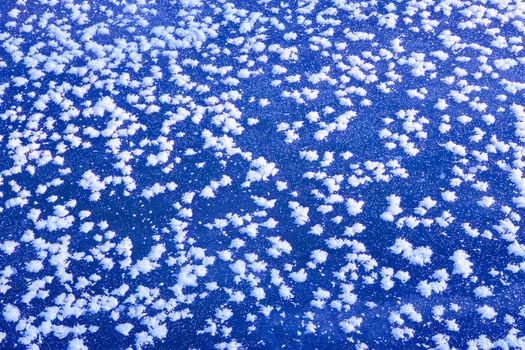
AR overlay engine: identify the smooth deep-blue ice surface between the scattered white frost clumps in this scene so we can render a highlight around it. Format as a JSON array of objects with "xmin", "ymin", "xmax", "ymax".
[{"xmin": 0, "ymin": 0, "xmax": 525, "ymax": 349}]
